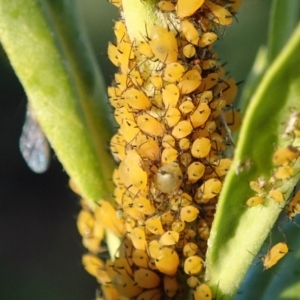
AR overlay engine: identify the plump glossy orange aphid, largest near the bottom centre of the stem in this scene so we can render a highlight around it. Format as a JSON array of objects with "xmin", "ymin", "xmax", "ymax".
[{"xmin": 155, "ymin": 247, "xmax": 179, "ymax": 276}]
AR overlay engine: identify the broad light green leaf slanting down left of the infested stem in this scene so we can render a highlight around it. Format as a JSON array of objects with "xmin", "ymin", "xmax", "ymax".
[{"xmin": 0, "ymin": 0, "xmax": 114, "ymax": 205}]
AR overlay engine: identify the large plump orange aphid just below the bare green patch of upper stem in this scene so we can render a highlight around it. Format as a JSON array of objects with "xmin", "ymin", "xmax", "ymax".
[{"xmin": 149, "ymin": 25, "xmax": 178, "ymax": 64}]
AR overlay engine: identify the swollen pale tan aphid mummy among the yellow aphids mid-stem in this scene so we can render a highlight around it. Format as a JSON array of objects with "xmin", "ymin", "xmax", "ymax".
[{"xmin": 155, "ymin": 162, "xmax": 182, "ymax": 193}]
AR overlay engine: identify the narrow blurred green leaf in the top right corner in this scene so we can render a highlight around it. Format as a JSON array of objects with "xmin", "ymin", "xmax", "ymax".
[{"xmin": 268, "ymin": 0, "xmax": 300, "ymax": 63}]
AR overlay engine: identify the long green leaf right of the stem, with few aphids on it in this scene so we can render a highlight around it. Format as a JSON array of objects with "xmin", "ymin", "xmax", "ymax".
[{"xmin": 206, "ymin": 22, "xmax": 300, "ymax": 299}]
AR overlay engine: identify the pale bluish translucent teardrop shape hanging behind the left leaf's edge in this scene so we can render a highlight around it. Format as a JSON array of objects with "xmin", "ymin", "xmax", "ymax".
[{"xmin": 19, "ymin": 104, "xmax": 50, "ymax": 173}]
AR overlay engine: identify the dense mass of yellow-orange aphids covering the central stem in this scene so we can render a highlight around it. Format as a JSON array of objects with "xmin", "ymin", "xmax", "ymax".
[{"xmin": 78, "ymin": 0, "xmax": 244, "ymax": 300}]
